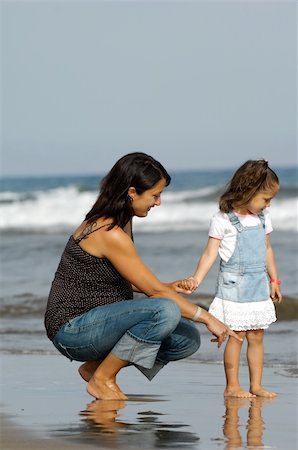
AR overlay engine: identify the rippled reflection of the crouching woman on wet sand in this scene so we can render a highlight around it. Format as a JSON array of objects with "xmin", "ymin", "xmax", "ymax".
[{"xmin": 80, "ymin": 397, "xmax": 200, "ymax": 449}]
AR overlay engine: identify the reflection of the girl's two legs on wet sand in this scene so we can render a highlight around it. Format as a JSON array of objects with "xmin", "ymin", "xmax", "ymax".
[{"xmin": 223, "ymin": 397, "xmax": 274, "ymax": 450}]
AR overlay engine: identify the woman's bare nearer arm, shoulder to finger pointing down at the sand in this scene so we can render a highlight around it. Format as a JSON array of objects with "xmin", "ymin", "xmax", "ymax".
[{"xmin": 101, "ymin": 227, "xmax": 239, "ymax": 346}]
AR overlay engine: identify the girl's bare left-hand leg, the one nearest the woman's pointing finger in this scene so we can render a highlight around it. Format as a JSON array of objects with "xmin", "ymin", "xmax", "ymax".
[{"xmin": 224, "ymin": 331, "xmax": 255, "ymax": 398}]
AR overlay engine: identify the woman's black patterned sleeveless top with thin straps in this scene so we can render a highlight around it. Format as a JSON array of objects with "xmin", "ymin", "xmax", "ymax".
[{"xmin": 45, "ymin": 230, "xmax": 133, "ymax": 340}]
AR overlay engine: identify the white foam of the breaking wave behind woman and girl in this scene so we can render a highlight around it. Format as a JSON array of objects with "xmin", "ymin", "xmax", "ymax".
[{"xmin": 0, "ymin": 186, "xmax": 298, "ymax": 232}]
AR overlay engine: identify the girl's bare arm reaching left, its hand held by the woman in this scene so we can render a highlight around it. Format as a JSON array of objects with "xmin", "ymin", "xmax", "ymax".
[{"xmin": 178, "ymin": 236, "xmax": 220, "ymax": 290}]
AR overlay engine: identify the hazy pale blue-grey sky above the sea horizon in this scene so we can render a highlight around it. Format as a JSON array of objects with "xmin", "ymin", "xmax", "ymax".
[{"xmin": 1, "ymin": 0, "xmax": 297, "ymax": 176}]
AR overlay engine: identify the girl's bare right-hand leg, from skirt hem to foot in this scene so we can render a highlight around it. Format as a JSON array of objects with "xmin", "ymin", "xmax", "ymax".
[{"xmin": 246, "ymin": 330, "xmax": 276, "ymax": 398}]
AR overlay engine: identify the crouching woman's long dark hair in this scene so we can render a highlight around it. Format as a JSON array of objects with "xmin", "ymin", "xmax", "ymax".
[{"xmin": 85, "ymin": 152, "xmax": 171, "ymax": 229}]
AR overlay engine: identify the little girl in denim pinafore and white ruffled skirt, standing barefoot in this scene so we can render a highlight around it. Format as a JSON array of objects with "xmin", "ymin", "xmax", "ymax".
[{"xmin": 180, "ymin": 160, "xmax": 282, "ymax": 398}]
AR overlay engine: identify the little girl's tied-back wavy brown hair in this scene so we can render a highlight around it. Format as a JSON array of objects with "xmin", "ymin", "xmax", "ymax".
[{"xmin": 219, "ymin": 159, "xmax": 279, "ymax": 213}]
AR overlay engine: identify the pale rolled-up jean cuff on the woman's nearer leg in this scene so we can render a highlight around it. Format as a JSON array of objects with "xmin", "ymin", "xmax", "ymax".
[{"xmin": 112, "ymin": 332, "xmax": 161, "ymax": 369}]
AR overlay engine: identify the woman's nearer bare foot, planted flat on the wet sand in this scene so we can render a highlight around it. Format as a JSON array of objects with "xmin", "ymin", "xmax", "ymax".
[{"xmin": 87, "ymin": 377, "xmax": 127, "ymax": 400}]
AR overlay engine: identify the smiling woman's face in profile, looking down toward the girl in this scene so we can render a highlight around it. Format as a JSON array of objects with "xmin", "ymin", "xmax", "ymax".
[{"xmin": 128, "ymin": 178, "xmax": 166, "ymax": 217}]
